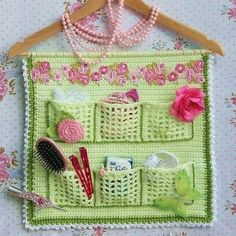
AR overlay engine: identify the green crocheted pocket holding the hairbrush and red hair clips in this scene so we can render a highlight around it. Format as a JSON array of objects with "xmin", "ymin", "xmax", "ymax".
[{"xmin": 49, "ymin": 171, "xmax": 94, "ymax": 207}]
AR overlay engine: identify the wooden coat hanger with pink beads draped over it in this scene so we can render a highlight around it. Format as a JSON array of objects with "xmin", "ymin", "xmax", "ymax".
[{"xmin": 8, "ymin": 0, "xmax": 224, "ymax": 59}]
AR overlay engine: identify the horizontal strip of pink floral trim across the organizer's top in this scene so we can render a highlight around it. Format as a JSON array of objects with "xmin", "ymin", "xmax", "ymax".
[{"xmin": 31, "ymin": 60, "xmax": 205, "ymax": 86}]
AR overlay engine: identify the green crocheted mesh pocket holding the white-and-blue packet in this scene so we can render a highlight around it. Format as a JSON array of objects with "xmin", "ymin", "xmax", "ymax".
[{"xmin": 96, "ymin": 168, "xmax": 141, "ymax": 206}]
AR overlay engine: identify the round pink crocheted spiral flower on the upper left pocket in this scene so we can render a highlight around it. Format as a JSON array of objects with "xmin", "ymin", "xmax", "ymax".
[{"xmin": 57, "ymin": 119, "xmax": 84, "ymax": 143}]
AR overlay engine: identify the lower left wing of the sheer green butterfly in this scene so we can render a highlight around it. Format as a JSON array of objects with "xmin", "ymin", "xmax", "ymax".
[{"xmin": 153, "ymin": 196, "xmax": 187, "ymax": 217}]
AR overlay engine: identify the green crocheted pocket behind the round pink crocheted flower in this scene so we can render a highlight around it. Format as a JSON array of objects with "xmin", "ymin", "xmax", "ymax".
[{"xmin": 48, "ymin": 101, "xmax": 95, "ymax": 142}]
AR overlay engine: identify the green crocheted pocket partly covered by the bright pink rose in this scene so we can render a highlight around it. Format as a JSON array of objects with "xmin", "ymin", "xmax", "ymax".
[{"xmin": 142, "ymin": 103, "xmax": 193, "ymax": 141}]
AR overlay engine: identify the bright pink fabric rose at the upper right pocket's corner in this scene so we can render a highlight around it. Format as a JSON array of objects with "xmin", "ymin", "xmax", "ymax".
[{"xmin": 170, "ymin": 86, "xmax": 205, "ymax": 122}]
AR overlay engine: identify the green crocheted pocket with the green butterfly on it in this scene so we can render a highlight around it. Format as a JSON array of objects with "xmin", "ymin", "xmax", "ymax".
[{"xmin": 142, "ymin": 163, "xmax": 194, "ymax": 205}]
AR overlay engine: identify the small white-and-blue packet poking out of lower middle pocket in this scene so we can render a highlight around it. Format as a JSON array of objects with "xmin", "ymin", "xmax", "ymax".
[{"xmin": 106, "ymin": 157, "xmax": 133, "ymax": 171}]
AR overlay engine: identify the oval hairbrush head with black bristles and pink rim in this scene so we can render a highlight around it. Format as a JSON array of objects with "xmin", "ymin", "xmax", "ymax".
[{"xmin": 35, "ymin": 137, "xmax": 68, "ymax": 174}]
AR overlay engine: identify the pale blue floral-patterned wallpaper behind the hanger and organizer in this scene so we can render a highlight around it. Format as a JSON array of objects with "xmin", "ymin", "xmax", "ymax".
[{"xmin": 0, "ymin": 0, "xmax": 236, "ymax": 236}]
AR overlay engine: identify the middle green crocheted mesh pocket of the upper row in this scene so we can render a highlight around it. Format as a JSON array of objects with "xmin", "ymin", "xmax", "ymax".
[{"xmin": 96, "ymin": 103, "xmax": 141, "ymax": 142}]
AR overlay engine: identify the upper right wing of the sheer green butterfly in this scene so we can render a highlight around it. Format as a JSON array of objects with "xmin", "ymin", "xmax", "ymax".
[{"xmin": 175, "ymin": 170, "xmax": 200, "ymax": 200}]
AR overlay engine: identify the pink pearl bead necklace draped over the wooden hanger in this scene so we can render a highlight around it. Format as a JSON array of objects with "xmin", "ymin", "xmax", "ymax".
[{"xmin": 62, "ymin": 0, "xmax": 158, "ymax": 64}]
